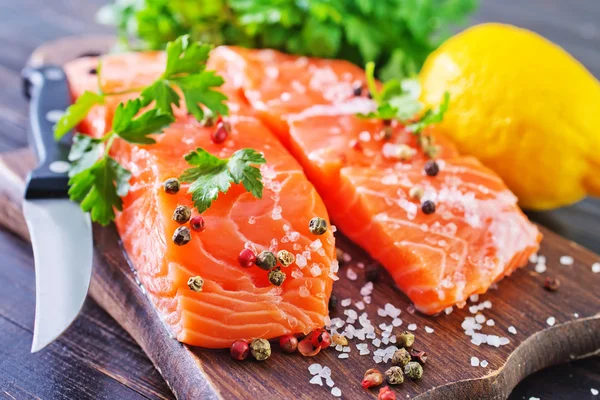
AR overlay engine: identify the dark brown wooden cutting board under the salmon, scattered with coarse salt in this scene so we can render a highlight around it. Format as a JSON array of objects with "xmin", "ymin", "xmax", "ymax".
[{"xmin": 0, "ymin": 38, "xmax": 600, "ymax": 399}]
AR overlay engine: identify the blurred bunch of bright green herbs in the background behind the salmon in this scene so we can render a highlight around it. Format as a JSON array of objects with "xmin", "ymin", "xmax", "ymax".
[{"xmin": 98, "ymin": 0, "xmax": 478, "ymax": 80}]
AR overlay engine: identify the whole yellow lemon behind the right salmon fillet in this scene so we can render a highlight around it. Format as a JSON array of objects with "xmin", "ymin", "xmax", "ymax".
[{"xmin": 419, "ymin": 24, "xmax": 600, "ymax": 210}]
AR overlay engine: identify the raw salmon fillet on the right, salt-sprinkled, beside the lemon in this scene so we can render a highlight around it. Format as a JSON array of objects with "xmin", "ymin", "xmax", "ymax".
[{"xmin": 212, "ymin": 47, "xmax": 541, "ymax": 314}]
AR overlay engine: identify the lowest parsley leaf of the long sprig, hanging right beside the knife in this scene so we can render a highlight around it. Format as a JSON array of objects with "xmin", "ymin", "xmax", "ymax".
[{"xmin": 69, "ymin": 157, "xmax": 131, "ymax": 225}]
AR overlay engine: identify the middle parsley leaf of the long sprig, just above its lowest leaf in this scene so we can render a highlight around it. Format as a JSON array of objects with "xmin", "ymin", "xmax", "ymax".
[{"xmin": 113, "ymin": 99, "xmax": 175, "ymax": 144}]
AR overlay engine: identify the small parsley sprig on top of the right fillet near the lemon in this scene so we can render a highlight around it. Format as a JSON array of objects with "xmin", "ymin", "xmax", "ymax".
[{"xmin": 359, "ymin": 62, "xmax": 450, "ymax": 156}]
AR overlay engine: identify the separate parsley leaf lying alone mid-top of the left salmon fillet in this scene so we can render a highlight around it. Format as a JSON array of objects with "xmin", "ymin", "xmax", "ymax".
[{"xmin": 179, "ymin": 148, "xmax": 266, "ymax": 213}]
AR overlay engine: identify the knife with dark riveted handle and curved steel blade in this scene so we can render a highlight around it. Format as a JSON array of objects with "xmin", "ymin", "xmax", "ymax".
[{"xmin": 23, "ymin": 66, "xmax": 93, "ymax": 353}]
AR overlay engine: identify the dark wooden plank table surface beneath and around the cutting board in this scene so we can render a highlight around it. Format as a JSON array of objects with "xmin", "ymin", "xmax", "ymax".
[{"xmin": 0, "ymin": 0, "xmax": 600, "ymax": 400}]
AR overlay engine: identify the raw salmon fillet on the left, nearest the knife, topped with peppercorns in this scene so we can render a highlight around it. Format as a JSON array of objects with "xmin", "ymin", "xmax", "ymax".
[{"xmin": 66, "ymin": 53, "xmax": 337, "ymax": 348}]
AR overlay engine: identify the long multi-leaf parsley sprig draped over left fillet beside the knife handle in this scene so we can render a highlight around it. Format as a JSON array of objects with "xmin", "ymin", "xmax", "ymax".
[{"xmin": 54, "ymin": 36, "xmax": 232, "ymax": 225}]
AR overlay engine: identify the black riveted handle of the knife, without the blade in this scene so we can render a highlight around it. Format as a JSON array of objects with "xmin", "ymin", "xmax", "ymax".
[{"xmin": 22, "ymin": 66, "xmax": 72, "ymax": 199}]
